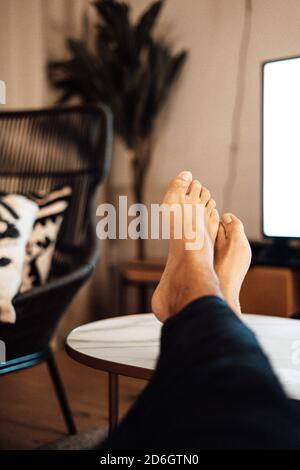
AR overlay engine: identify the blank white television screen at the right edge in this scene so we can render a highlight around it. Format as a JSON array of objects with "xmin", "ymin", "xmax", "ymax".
[{"xmin": 263, "ymin": 57, "xmax": 300, "ymax": 238}]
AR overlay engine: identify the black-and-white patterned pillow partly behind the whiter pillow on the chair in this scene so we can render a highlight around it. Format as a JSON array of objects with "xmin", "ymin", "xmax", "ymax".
[{"xmin": 20, "ymin": 186, "xmax": 72, "ymax": 292}]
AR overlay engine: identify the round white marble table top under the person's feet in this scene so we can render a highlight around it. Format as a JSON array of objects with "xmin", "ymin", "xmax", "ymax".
[{"xmin": 67, "ymin": 314, "xmax": 300, "ymax": 400}]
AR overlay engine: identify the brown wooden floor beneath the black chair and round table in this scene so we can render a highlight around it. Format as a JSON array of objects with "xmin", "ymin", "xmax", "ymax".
[{"xmin": 0, "ymin": 351, "xmax": 145, "ymax": 450}]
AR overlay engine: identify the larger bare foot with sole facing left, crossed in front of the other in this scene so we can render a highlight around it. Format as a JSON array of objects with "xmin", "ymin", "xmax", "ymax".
[{"xmin": 152, "ymin": 172, "xmax": 222, "ymax": 322}]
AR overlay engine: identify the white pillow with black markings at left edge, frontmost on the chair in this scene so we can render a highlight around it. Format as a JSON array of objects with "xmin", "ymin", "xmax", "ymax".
[{"xmin": 0, "ymin": 194, "xmax": 39, "ymax": 323}]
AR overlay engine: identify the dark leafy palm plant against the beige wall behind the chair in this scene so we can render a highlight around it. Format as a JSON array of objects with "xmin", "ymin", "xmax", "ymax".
[{"xmin": 48, "ymin": 0, "xmax": 187, "ymax": 258}]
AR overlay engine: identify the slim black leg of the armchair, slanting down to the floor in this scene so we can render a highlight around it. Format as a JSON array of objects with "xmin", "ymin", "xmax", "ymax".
[{"xmin": 47, "ymin": 352, "xmax": 77, "ymax": 434}]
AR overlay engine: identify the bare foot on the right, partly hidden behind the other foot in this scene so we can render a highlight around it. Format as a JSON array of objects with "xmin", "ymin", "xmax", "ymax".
[{"xmin": 214, "ymin": 214, "xmax": 251, "ymax": 313}]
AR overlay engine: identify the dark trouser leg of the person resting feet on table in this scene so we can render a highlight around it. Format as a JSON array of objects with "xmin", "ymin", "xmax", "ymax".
[{"xmin": 101, "ymin": 297, "xmax": 300, "ymax": 451}]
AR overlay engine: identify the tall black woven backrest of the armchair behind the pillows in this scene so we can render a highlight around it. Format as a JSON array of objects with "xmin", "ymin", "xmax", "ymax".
[{"xmin": 0, "ymin": 107, "xmax": 112, "ymax": 274}]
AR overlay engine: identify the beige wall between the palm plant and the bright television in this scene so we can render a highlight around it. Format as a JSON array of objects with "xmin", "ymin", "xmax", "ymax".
[{"xmin": 122, "ymin": 0, "xmax": 300, "ymax": 249}]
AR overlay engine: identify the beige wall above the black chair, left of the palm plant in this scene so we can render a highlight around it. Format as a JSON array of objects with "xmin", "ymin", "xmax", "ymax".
[{"xmin": 0, "ymin": 0, "xmax": 88, "ymax": 109}]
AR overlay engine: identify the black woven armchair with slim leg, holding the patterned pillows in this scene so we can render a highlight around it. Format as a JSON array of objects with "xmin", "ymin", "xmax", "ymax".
[{"xmin": 0, "ymin": 107, "xmax": 112, "ymax": 434}]
